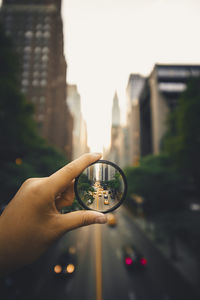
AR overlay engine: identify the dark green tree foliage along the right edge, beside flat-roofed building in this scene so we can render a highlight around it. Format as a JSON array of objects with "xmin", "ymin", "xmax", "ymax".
[{"xmin": 164, "ymin": 78, "xmax": 200, "ymax": 197}]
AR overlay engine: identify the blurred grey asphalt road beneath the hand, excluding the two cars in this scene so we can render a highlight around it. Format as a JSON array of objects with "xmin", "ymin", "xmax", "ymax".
[{"xmin": 1, "ymin": 208, "xmax": 199, "ymax": 300}]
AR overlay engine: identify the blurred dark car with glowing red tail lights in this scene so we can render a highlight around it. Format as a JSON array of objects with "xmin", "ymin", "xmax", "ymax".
[{"xmin": 122, "ymin": 245, "xmax": 147, "ymax": 270}]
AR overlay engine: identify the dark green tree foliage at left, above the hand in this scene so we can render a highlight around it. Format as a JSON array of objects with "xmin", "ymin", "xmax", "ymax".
[{"xmin": 0, "ymin": 27, "xmax": 67, "ymax": 204}]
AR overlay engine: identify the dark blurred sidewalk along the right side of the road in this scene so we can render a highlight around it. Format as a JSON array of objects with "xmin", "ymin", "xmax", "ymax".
[{"xmin": 134, "ymin": 217, "xmax": 200, "ymax": 290}]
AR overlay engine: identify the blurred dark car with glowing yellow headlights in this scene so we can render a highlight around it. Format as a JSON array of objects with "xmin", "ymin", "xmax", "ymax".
[{"xmin": 53, "ymin": 247, "xmax": 77, "ymax": 278}]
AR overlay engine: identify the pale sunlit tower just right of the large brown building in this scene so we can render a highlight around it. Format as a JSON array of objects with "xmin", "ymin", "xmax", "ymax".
[{"xmin": 67, "ymin": 84, "xmax": 89, "ymax": 159}]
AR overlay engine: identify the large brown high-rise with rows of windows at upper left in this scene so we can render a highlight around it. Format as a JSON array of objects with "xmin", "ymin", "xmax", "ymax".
[{"xmin": 0, "ymin": 0, "xmax": 73, "ymax": 159}]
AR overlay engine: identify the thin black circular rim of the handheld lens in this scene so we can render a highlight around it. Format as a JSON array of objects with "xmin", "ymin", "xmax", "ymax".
[{"xmin": 74, "ymin": 159, "xmax": 128, "ymax": 214}]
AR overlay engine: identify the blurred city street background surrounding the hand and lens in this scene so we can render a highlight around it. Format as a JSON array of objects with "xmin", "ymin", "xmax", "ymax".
[{"xmin": 0, "ymin": 0, "xmax": 200, "ymax": 300}]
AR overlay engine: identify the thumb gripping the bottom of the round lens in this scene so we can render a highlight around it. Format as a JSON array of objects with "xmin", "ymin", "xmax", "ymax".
[{"xmin": 60, "ymin": 210, "xmax": 107, "ymax": 233}]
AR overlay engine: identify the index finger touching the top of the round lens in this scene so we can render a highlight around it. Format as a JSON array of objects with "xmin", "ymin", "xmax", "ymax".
[{"xmin": 49, "ymin": 153, "xmax": 102, "ymax": 193}]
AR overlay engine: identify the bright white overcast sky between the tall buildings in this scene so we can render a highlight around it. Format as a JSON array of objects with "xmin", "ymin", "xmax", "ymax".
[{"xmin": 63, "ymin": 0, "xmax": 200, "ymax": 151}]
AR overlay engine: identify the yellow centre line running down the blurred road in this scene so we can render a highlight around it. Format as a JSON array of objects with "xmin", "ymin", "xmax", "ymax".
[{"xmin": 95, "ymin": 225, "xmax": 102, "ymax": 300}]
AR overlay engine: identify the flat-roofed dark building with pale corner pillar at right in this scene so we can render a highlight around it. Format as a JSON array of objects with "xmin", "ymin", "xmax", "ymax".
[{"xmin": 149, "ymin": 64, "xmax": 200, "ymax": 154}]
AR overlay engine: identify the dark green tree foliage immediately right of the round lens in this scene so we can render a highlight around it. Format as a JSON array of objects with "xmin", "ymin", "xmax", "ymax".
[{"xmin": 125, "ymin": 154, "xmax": 183, "ymax": 217}]
